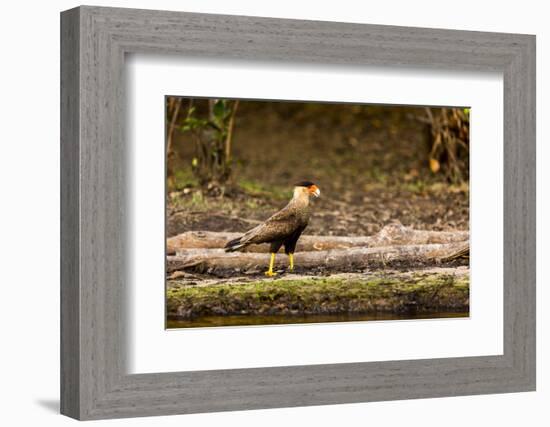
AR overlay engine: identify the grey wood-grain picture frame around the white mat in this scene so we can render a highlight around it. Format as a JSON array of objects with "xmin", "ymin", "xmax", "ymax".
[{"xmin": 61, "ymin": 6, "xmax": 535, "ymax": 420}]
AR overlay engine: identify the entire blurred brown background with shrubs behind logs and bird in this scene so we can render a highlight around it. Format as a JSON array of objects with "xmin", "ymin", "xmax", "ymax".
[{"xmin": 166, "ymin": 97, "xmax": 470, "ymax": 235}]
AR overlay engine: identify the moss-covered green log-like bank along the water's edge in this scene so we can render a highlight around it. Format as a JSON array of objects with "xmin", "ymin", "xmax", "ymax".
[{"xmin": 167, "ymin": 274, "xmax": 469, "ymax": 319}]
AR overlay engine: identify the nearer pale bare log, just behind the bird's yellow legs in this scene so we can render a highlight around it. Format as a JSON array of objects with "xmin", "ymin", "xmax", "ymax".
[{"xmin": 166, "ymin": 242, "xmax": 469, "ymax": 273}]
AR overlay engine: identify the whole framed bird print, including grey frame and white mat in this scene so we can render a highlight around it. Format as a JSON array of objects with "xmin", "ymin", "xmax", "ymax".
[{"xmin": 61, "ymin": 6, "xmax": 535, "ymax": 419}]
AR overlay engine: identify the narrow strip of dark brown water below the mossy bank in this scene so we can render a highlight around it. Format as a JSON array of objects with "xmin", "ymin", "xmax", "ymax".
[{"xmin": 166, "ymin": 311, "xmax": 469, "ymax": 329}]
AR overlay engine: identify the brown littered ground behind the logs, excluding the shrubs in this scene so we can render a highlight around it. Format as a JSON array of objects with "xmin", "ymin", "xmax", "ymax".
[{"xmin": 167, "ymin": 103, "xmax": 469, "ymax": 237}]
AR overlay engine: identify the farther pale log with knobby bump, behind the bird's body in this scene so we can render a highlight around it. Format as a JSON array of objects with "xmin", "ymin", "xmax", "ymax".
[{"xmin": 167, "ymin": 222, "xmax": 469, "ymax": 255}]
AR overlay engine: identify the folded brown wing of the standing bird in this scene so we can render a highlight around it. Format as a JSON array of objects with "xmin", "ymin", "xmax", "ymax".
[{"xmin": 241, "ymin": 207, "xmax": 300, "ymax": 244}]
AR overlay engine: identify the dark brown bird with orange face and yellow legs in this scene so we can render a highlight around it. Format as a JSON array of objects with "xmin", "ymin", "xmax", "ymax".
[{"xmin": 225, "ymin": 181, "xmax": 321, "ymax": 277}]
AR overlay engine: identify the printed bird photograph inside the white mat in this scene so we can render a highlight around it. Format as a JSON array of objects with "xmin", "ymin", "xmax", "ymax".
[{"xmin": 164, "ymin": 96, "xmax": 470, "ymax": 329}]
